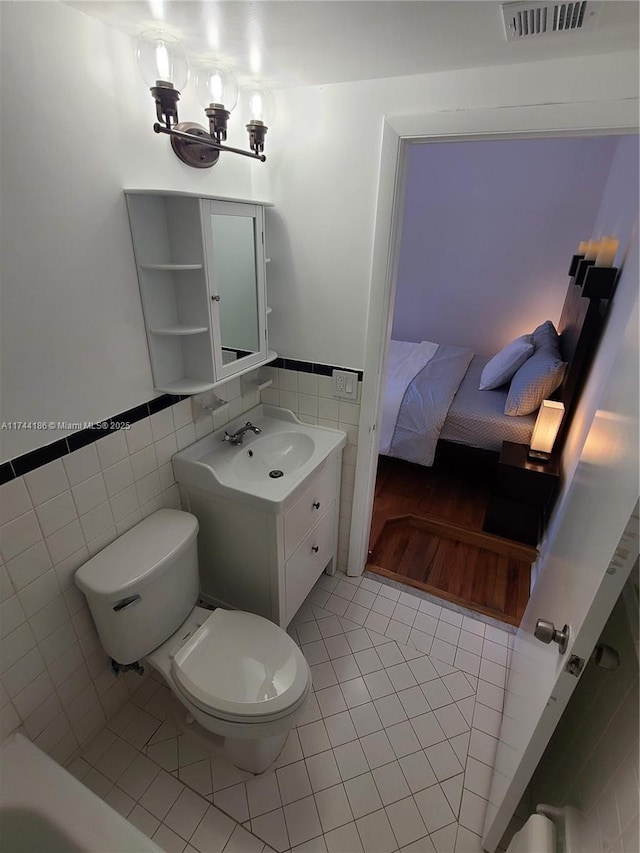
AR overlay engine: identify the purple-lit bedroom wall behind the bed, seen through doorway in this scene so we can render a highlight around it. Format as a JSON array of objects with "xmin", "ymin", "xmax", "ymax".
[{"xmin": 392, "ymin": 136, "xmax": 618, "ymax": 356}]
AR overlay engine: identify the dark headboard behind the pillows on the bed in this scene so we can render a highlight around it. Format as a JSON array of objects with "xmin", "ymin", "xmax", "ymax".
[{"xmin": 553, "ymin": 269, "xmax": 613, "ymax": 450}]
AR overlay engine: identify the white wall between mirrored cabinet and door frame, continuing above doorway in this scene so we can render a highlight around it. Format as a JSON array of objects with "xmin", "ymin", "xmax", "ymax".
[{"xmin": 252, "ymin": 52, "xmax": 638, "ymax": 368}]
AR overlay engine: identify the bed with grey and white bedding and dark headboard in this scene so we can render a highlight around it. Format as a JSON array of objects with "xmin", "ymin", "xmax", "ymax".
[{"xmin": 379, "ymin": 264, "xmax": 611, "ymax": 466}]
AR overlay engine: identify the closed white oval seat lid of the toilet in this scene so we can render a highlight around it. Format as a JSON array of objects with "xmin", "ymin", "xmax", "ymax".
[{"xmin": 171, "ymin": 608, "xmax": 310, "ymax": 723}]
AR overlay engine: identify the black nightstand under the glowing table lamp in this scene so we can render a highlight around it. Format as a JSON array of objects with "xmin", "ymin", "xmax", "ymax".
[{"xmin": 482, "ymin": 441, "xmax": 560, "ymax": 545}]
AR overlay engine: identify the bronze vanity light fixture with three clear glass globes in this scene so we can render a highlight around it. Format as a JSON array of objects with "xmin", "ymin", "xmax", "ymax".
[{"xmin": 136, "ymin": 30, "xmax": 268, "ymax": 169}]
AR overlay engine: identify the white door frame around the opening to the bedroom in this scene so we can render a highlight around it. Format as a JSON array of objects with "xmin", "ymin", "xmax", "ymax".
[{"xmin": 347, "ymin": 99, "xmax": 638, "ymax": 577}]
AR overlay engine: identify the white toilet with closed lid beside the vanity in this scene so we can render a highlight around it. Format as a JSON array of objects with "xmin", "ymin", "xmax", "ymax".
[{"xmin": 75, "ymin": 509, "xmax": 311, "ymax": 773}]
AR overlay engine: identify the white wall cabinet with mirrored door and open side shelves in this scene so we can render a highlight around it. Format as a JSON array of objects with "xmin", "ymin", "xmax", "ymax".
[{"xmin": 125, "ymin": 190, "xmax": 276, "ymax": 394}]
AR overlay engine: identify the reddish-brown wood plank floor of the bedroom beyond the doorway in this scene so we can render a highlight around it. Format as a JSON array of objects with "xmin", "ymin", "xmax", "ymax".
[{"xmin": 367, "ymin": 456, "xmax": 536, "ymax": 625}]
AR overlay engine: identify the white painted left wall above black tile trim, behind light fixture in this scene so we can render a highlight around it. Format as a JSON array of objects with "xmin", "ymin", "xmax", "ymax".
[{"xmin": 0, "ymin": 2, "xmax": 251, "ymax": 466}]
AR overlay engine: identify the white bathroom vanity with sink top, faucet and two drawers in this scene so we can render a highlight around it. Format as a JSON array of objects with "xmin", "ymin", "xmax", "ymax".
[{"xmin": 173, "ymin": 405, "xmax": 346, "ymax": 627}]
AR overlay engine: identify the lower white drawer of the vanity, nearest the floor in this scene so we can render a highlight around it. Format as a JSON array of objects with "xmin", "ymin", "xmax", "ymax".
[{"xmin": 284, "ymin": 503, "xmax": 336, "ymax": 624}]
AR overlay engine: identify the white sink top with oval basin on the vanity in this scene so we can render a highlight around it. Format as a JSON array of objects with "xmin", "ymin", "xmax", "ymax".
[{"xmin": 173, "ymin": 405, "xmax": 347, "ymax": 513}]
